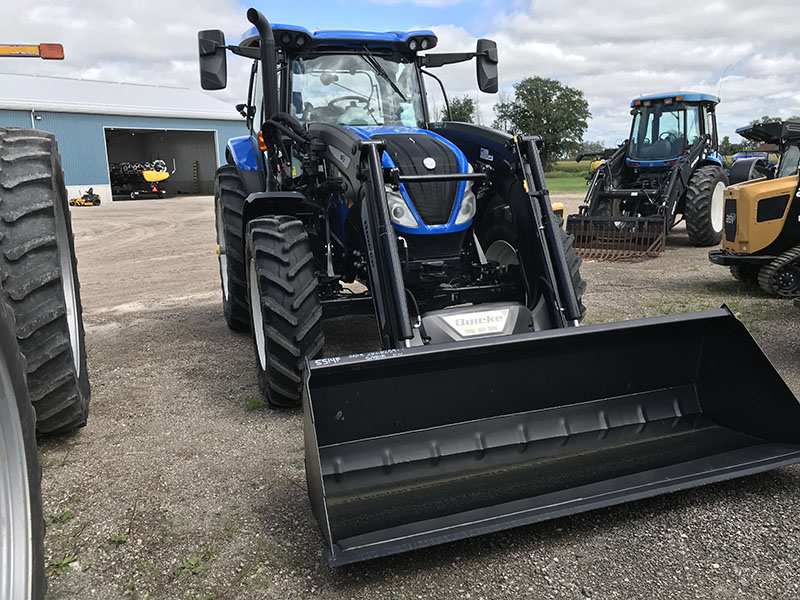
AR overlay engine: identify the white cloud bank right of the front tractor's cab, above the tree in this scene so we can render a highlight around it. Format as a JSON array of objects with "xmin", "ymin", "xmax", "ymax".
[{"xmin": 424, "ymin": 0, "xmax": 800, "ymax": 144}]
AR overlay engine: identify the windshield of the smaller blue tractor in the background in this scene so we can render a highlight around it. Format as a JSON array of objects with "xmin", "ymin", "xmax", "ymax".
[{"xmin": 630, "ymin": 104, "xmax": 700, "ymax": 160}]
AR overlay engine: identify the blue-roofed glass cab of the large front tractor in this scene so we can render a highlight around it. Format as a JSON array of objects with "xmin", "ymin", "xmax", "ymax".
[{"xmin": 240, "ymin": 24, "xmax": 444, "ymax": 128}]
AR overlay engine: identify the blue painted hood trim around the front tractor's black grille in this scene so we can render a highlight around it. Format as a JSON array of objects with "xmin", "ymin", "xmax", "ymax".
[{"xmin": 347, "ymin": 125, "xmax": 472, "ymax": 235}]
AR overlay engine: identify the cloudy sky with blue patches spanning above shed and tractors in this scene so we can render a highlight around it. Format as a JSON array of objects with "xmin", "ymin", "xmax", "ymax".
[{"xmin": 0, "ymin": 0, "xmax": 800, "ymax": 145}]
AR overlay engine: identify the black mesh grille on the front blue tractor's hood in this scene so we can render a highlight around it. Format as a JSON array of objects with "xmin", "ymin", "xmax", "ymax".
[{"xmin": 373, "ymin": 134, "xmax": 459, "ymax": 225}]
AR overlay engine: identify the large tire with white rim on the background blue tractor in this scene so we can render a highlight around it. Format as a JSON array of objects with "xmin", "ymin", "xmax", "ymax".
[{"xmin": 683, "ymin": 165, "xmax": 728, "ymax": 246}]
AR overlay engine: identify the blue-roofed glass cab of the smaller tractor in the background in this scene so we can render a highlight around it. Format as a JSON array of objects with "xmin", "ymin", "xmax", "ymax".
[{"xmin": 626, "ymin": 92, "xmax": 719, "ymax": 168}]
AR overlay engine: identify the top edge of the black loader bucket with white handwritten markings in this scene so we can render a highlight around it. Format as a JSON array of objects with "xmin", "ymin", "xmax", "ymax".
[{"xmin": 308, "ymin": 304, "xmax": 739, "ymax": 375}]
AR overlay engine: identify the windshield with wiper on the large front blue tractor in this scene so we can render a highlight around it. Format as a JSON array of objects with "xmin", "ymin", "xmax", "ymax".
[{"xmin": 291, "ymin": 50, "xmax": 425, "ymax": 127}]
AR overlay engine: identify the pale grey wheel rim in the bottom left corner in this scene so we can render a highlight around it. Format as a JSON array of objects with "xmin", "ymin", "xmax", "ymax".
[{"xmin": 0, "ymin": 364, "xmax": 33, "ymax": 598}]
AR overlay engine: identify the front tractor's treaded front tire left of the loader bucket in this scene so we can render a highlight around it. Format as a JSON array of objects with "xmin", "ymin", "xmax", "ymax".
[{"xmin": 247, "ymin": 216, "xmax": 324, "ymax": 407}]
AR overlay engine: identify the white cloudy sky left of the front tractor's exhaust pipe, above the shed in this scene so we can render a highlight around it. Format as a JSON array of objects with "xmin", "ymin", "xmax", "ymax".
[{"xmin": 0, "ymin": 0, "xmax": 249, "ymax": 103}]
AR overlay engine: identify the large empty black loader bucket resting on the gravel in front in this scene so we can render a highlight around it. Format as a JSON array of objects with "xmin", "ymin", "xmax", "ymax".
[{"xmin": 303, "ymin": 308, "xmax": 800, "ymax": 565}]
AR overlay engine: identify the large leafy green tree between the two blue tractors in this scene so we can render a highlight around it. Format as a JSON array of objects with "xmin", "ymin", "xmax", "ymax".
[{"xmin": 494, "ymin": 77, "xmax": 592, "ymax": 168}]
